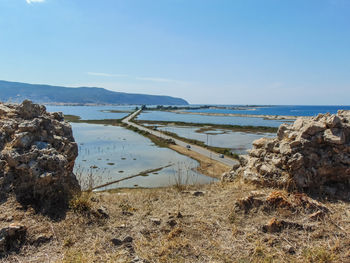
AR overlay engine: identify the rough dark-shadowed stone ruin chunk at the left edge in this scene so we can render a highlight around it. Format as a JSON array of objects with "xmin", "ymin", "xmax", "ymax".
[{"xmin": 0, "ymin": 101, "xmax": 80, "ymax": 217}]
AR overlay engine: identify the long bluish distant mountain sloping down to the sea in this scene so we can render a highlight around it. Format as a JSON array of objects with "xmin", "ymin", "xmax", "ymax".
[{"xmin": 0, "ymin": 80, "xmax": 188, "ymax": 105}]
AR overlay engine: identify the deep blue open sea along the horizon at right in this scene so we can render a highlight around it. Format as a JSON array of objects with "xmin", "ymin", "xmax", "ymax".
[{"xmin": 183, "ymin": 106, "xmax": 350, "ymax": 116}]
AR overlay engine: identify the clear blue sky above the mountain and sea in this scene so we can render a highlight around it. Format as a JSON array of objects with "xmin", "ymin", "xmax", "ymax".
[{"xmin": 0, "ymin": 0, "xmax": 350, "ymax": 105}]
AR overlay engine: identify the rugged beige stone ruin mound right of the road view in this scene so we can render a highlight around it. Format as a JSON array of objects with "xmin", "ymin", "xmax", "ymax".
[{"xmin": 222, "ymin": 110, "xmax": 350, "ymax": 199}]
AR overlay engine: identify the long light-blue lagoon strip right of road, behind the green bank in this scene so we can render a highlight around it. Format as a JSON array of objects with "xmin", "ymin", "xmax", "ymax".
[{"xmin": 137, "ymin": 111, "xmax": 285, "ymax": 127}]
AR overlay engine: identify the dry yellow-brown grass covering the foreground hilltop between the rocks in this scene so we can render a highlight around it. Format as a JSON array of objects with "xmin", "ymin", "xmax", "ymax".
[{"xmin": 0, "ymin": 179, "xmax": 350, "ymax": 263}]
